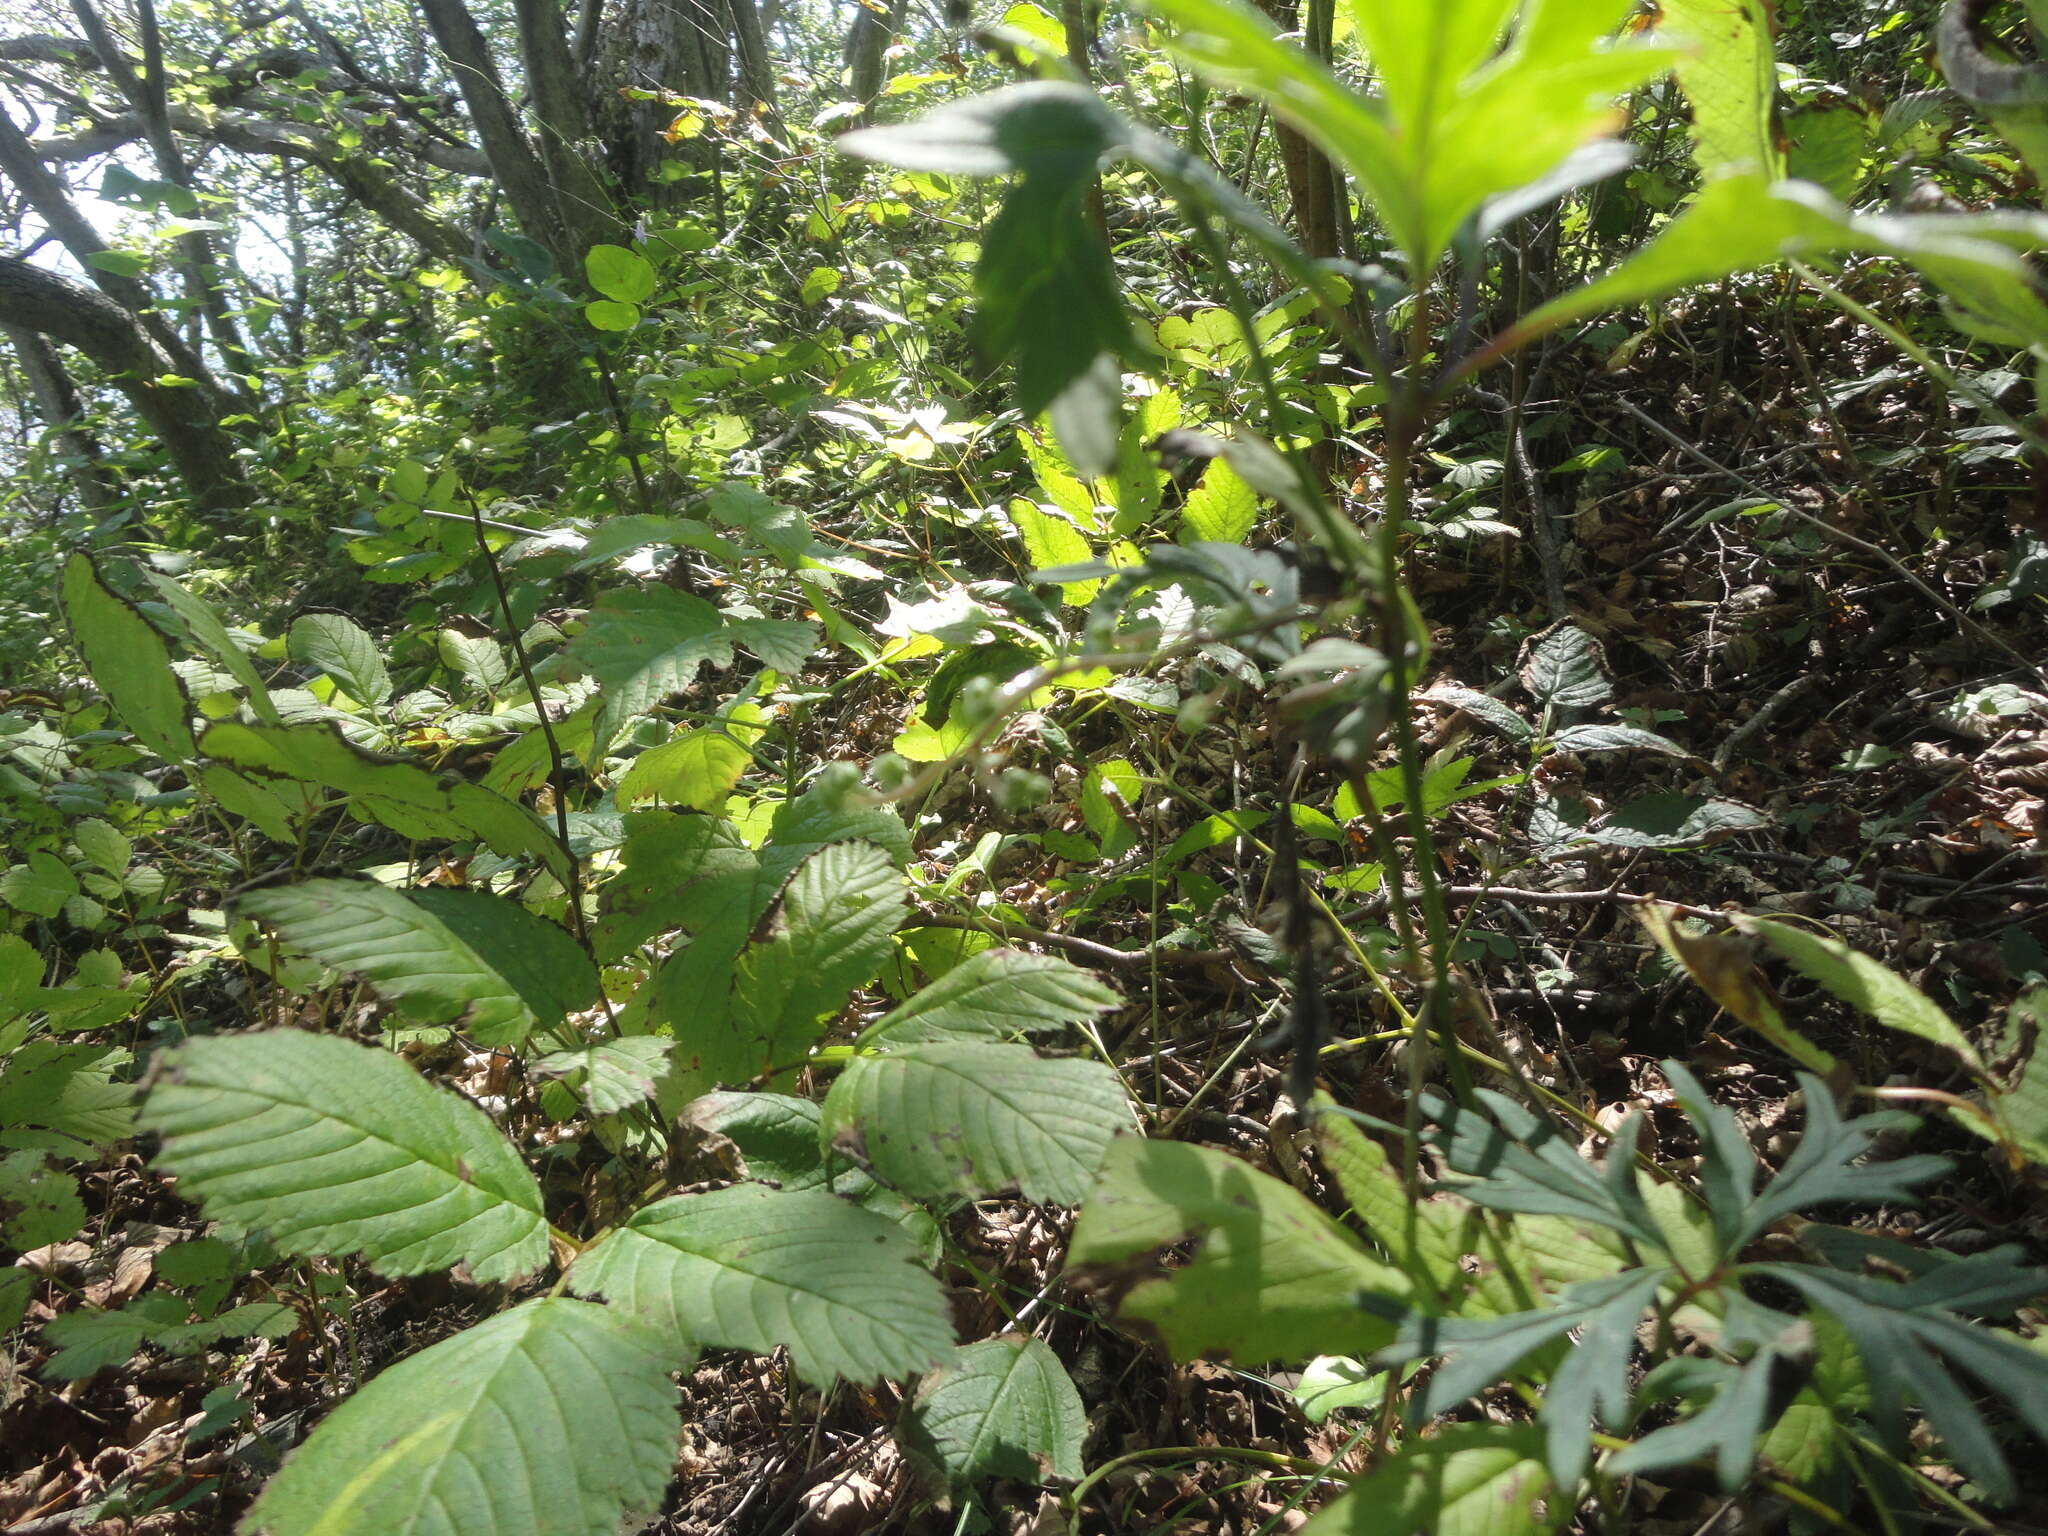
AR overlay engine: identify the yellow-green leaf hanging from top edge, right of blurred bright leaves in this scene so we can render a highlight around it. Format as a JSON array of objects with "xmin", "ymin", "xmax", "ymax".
[{"xmin": 1657, "ymin": 0, "xmax": 1784, "ymax": 178}]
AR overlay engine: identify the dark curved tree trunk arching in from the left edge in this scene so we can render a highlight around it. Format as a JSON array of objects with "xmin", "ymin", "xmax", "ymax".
[{"xmin": 0, "ymin": 256, "xmax": 250, "ymax": 512}]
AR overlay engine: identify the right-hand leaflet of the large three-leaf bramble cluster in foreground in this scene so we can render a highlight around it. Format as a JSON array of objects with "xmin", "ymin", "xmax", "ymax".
[{"xmin": 569, "ymin": 1184, "xmax": 952, "ymax": 1386}]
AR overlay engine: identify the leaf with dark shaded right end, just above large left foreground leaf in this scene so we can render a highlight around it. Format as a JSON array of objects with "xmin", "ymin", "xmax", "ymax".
[{"xmin": 236, "ymin": 881, "xmax": 598, "ymax": 1047}]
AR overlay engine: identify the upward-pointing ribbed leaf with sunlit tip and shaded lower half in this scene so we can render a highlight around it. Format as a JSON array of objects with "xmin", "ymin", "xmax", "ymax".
[{"xmin": 729, "ymin": 842, "xmax": 909, "ymax": 1081}]
